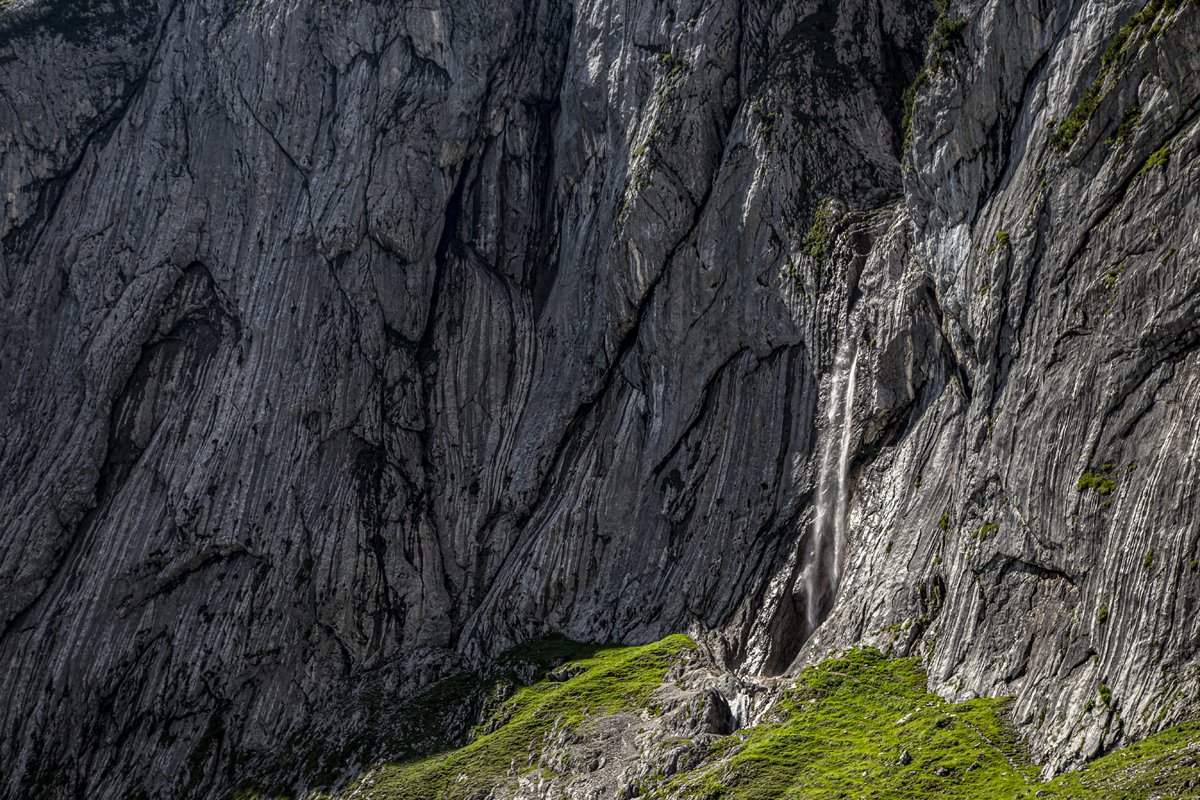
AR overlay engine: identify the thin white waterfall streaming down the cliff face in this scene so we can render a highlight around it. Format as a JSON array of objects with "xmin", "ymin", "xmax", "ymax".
[{"xmin": 806, "ymin": 336, "xmax": 858, "ymax": 634}]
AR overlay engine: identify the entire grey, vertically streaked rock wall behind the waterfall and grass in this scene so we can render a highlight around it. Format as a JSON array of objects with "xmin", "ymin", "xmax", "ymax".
[{"xmin": 0, "ymin": 0, "xmax": 1200, "ymax": 798}]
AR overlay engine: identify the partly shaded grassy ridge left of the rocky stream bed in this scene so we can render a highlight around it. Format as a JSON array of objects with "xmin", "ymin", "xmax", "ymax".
[{"xmin": 233, "ymin": 634, "xmax": 695, "ymax": 800}]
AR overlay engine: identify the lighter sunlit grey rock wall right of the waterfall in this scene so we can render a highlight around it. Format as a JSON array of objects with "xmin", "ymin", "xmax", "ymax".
[{"xmin": 811, "ymin": 4, "xmax": 1200, "ymax": 770}]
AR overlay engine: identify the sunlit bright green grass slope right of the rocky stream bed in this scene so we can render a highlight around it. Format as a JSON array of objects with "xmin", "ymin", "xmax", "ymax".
[{"xmin": 648, "ymin": 649, "xmax": 1200, "ymax": 800}]
